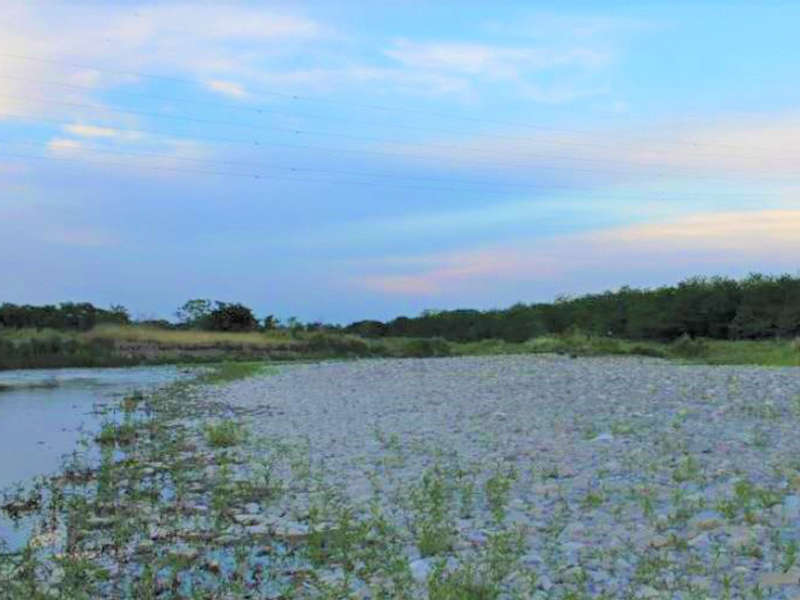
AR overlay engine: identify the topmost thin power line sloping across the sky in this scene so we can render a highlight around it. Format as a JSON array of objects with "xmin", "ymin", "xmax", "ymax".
[{"xmin": 0, "ymin": 52, "xmax": 796, "ymax": 156}]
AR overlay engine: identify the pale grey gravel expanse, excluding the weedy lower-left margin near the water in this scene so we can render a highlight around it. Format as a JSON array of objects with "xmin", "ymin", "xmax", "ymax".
[{"xmin": 214, "ymin": 355, "xmax": 800, "ymax": 599}]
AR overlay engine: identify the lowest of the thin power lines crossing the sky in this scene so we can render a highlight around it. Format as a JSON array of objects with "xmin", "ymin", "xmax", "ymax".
[{"xmin": 0, "ymin": 140, "xmax": 792, "ymax": 201}]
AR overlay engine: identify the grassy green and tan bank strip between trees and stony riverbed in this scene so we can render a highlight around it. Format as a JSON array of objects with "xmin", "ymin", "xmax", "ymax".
[{"xmin": 0, "ymin": 326, "xmax": 800, "ymax": 370}]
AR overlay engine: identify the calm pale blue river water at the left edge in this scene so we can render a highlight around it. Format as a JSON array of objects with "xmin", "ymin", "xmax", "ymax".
[{"xmin": 0, "ymin": 366, "xmax": 185, "ymax": 543}]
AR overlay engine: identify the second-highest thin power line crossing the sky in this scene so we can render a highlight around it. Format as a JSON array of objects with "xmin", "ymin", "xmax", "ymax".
[{"xmin": 0, "ymin": 71, "xmax": 799, "ymax": 160}]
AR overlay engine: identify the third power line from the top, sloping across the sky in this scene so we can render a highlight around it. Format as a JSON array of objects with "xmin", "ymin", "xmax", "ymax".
[{"xmin": 0, "ymin": 94, "xmax": 800, "ymax": 180}]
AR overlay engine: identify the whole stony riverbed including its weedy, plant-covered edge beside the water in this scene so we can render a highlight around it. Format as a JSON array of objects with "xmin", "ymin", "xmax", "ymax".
[{"xmin": 0, "ymin": 356, "xmax": 800, "ymax": 600}]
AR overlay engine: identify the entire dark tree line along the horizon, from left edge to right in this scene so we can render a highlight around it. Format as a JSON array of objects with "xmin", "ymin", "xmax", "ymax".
[{"xmin": 6, "ymin": 274, "xmax": 800, "ymax": 342}]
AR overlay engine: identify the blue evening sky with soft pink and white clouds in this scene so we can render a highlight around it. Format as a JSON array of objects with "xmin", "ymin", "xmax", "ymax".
[{"xmin": 0, "ymin": 0, "xmax": 800, "ymax": 323}]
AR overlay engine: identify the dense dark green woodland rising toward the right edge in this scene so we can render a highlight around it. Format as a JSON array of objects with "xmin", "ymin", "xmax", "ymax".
[{"xmin": 345, "ymin": 275, "xmax": 800, "ymax": 342}]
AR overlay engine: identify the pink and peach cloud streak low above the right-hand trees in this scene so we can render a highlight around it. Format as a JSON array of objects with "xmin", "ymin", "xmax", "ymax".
[{"xmin": 358, "ymin": 210, "xmax": 800, "ymax": 296}]
